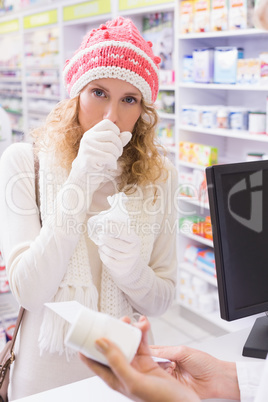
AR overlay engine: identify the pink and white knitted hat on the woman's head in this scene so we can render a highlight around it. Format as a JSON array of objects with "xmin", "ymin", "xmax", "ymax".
[{"xmin": 63, "ymin": 17, "xmax": 161, "ymax": 103}]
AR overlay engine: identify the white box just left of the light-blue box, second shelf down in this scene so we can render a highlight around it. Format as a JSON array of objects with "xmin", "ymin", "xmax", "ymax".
[{"xmin": 193, "ymin": 48, "xmax": 214, "ymax": 83}]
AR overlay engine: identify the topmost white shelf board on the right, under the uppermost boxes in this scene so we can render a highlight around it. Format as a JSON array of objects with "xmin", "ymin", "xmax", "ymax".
[{"xmin": 178, "ymin": 28, "xmax": 268, "ymax": 40}]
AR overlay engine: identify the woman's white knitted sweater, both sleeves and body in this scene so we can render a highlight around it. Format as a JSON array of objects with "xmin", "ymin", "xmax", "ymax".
[{"xmin": 0, "ymin": 144, "xmax": 177, "ymax": 400}]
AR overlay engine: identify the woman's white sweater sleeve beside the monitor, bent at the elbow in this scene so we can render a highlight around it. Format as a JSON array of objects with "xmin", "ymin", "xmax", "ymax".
[{"xmin": 106, "ymin": 161, "xmax": 178, "ymax": 316}]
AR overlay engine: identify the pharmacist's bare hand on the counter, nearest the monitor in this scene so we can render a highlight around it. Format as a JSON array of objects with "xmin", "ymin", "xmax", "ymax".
[{"xmin": 150, "ymin": 345, "xmax": 240, "ymax": 400}]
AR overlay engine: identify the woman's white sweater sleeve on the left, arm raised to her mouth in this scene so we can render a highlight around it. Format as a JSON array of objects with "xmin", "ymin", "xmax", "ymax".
[{"xmin": 0, "ymin": 143, "xmax": 86, "ymax": 311}]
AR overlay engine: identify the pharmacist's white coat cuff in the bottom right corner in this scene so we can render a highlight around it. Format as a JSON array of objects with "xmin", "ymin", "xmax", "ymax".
[{"xmin": 236, "ymin": 361, "xmax": 265, "ymax": 402}]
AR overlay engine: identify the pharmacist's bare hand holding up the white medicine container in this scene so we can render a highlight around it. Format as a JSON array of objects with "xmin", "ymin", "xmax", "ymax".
[{"xmin": 80, "ymin": 317, "xmax": 199, "ymax": 402}]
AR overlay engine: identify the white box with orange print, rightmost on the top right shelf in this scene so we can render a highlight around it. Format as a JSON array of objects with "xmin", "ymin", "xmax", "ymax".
[{"xmin": 228, "ymin": 0, "xmax": 255, "ymax": 29}]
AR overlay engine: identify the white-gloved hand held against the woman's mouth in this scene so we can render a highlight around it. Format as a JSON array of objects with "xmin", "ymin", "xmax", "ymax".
[{"xmin": 72, "ymin": 119, "xmax": 131, "ymax": 182}]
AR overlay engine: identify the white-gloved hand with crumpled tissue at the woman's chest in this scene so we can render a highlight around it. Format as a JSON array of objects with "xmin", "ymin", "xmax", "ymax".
[{"xmin": 88, "ymin": 193, "xmax": 141, "ymax": 275}]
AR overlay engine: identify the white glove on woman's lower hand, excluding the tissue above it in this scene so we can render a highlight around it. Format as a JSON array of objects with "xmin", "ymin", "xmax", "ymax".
[{"xmin": 98, "ymin": 221, "xmax": 141, "ymax": 276}]
